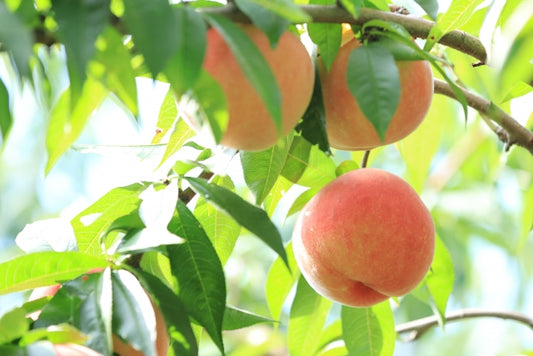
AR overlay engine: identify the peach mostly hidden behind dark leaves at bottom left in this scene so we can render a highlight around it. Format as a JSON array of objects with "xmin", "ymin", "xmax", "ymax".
[{"xmin": 29, "ymin": 269, "xmax": 170, "ymax": 356}]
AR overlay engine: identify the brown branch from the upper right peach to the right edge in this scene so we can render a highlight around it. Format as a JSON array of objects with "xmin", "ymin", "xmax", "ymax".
[{"xmin": 434, "ymin": 79, "xmax": 533, "ymax": 154}]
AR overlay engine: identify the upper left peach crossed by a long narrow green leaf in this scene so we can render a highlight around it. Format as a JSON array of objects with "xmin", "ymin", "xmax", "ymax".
[{"xmin": 183, "ymin": 25, "xmax": 315, "ymax": 151}]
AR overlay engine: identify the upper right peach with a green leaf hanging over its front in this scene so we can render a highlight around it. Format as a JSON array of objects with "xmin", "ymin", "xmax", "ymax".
[{"xmin": 318, "ymin": 31, "xmax": 433, "ymax": 151}]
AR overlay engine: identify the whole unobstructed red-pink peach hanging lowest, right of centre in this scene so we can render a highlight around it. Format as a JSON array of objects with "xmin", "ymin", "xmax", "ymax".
[{"xmin": 292, "ymin": 168, "xmax": 435, "ymax": 307}]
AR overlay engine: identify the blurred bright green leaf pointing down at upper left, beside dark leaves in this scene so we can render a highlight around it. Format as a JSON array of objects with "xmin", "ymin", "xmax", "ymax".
[{"xmin": 89, "ymin": 26, "xmax": 138, "ymax": 115}]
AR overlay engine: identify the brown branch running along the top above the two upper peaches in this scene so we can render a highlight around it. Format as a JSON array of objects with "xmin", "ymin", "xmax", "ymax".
[{"xmin": 199, "ymin": 5, "xmax": 487, "ymax": 64}]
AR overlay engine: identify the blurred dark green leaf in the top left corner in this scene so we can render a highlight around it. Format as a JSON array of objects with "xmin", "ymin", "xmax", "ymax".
[{"xmin": 0, "ymin": 2, "xmax": 33, "ymax": 77}]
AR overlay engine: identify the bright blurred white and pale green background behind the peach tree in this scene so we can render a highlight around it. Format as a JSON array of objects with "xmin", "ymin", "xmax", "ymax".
[{"xmin": 0, "ymin": 1, "xmax": 533, "ymax": 355}]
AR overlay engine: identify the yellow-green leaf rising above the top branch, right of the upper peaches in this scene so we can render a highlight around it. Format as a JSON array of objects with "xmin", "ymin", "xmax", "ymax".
[{"xmin": 424, "ymin": 0, "xmax": 483, "ymax": 51}]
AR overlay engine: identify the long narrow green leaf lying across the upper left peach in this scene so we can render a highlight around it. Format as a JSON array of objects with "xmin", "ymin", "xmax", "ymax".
[{"xmin": 202, "ymin": 12, "xmax": 281, "ymax": 130}]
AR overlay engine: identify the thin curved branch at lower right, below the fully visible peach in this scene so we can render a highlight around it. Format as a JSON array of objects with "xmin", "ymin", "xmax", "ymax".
[{"xmin": 396, "ymin": 309, "xmax": 533, "ymax": 342}]
